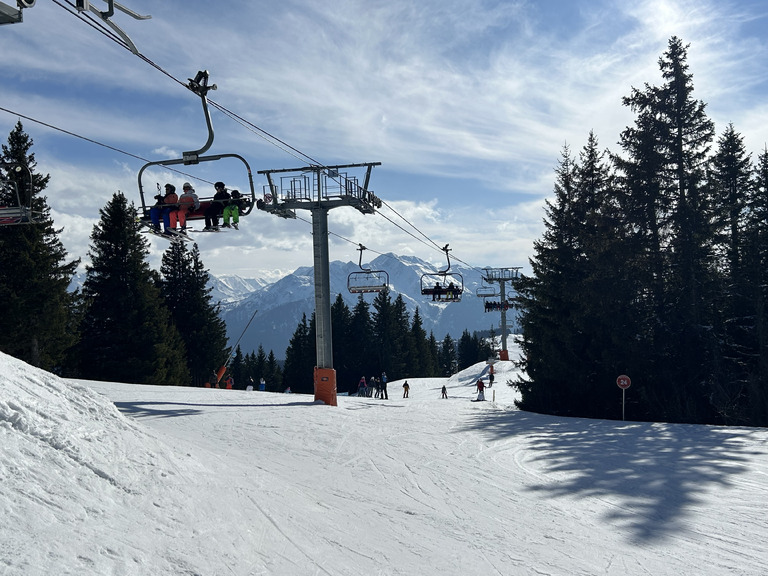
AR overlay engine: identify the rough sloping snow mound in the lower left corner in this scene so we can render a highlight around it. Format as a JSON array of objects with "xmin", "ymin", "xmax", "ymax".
[{"xmin": 0, "ymin": 353, "xmax": 201, "ymax": 575}]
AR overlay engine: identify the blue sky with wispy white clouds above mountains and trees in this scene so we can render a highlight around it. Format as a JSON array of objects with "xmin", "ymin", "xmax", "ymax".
[{"xmin": 0, "ymin": 0, "xmax": 768, "ymax": 278}]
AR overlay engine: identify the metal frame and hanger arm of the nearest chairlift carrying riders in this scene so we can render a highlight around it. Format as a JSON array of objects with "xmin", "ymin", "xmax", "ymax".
[{"xmin": 138, "ymin": 70, "xmax": 256, "ymax": 231}]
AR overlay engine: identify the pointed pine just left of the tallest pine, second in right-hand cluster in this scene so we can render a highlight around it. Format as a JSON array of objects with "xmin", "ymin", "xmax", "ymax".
[{"xmin": 560, "ymin": 133, "xmax": 637, "ymax": 417}]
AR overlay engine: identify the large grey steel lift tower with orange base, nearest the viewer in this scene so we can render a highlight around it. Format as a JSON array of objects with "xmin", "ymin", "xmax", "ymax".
[{"xmin": 256, "ymin": 162, "xmax": 381, "ymax": 406}]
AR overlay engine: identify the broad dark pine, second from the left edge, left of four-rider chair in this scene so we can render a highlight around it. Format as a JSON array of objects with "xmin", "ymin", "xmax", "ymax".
[{"xmin": 79, "ymin": 192, "xmax": 189, "ymax": 385}]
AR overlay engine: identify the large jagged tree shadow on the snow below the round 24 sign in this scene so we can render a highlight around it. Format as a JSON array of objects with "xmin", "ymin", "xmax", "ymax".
[{"xmin": 465, "ymin": 411, "xmax": 766, "ymax": 541}]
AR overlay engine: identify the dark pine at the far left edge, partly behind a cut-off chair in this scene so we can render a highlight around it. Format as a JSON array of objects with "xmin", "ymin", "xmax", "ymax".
[{"xmin": 0, "ymin": 121, "xmax": 79, "ymax": 373}]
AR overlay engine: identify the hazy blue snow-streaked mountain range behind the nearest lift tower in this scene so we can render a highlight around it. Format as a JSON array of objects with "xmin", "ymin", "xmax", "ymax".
[{"xmin": 214, "ymin": 254, "xmax": 514, "ymax": 358}]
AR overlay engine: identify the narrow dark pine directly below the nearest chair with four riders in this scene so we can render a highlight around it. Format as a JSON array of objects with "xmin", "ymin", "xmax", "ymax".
[{"xmin": 160, "ymin": 242, "xmax": 226, "ymax": 386}]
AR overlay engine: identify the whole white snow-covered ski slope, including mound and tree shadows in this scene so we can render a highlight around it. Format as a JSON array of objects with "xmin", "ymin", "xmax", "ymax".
[{"xmin": 0, "ymin": 346, "xmax": 768, "ymax": 576}]
